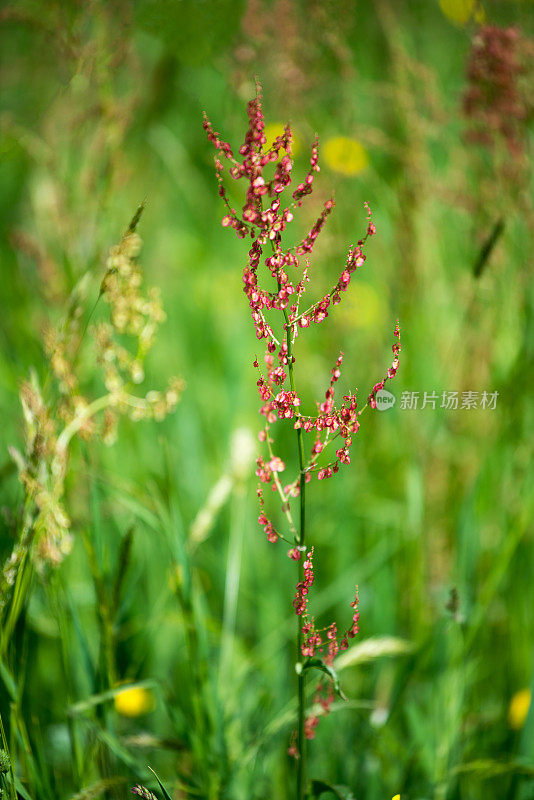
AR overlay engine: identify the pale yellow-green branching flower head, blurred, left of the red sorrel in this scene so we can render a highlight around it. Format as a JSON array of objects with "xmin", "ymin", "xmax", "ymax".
[{"xmin": 0, "ymin": 207, "xmax": 183, "ymax": 610}]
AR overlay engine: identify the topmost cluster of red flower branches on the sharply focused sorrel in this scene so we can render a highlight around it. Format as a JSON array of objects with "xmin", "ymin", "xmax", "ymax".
[{"xmin": 204, "ymin": 85, "xmax": 375, "ymax": 342}]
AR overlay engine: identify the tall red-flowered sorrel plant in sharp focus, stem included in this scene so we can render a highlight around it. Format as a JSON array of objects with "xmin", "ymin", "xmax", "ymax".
[{"xmin": 204, "ymin": 84, "xmax": 400, "ymax": 800}]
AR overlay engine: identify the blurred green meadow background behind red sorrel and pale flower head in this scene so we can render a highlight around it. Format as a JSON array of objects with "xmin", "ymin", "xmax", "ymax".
[{"xmin": 0, "ymin": 0, "xmax": 534, "ymax": 800}]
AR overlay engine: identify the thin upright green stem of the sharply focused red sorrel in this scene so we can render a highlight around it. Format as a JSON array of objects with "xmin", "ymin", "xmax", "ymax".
[{"xmin": 284, "ymin": 309, "xmax": 306, "ymax": 800}]
